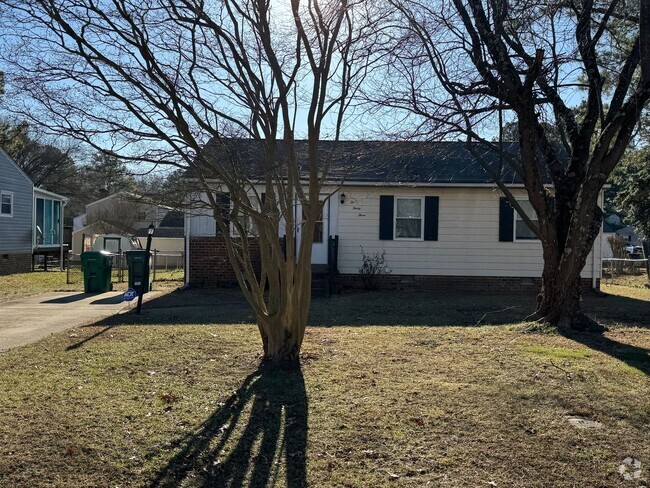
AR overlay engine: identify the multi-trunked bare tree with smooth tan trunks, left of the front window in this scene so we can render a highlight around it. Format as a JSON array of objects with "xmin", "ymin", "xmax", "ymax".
[{"xmin": 0, "ymin": 0, "xmax": 373, "ymax": 360}]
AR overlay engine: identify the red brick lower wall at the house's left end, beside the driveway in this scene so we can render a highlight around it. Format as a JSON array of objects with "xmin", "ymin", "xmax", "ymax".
[{"xmin": 190, "ymin": 236, "xmax": 261, "ymax": 287}]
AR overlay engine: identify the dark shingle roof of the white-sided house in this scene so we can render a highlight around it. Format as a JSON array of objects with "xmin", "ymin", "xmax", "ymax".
[{"xmin": 185, "ymin": 139, "xmax": 550, "ymax": 184}]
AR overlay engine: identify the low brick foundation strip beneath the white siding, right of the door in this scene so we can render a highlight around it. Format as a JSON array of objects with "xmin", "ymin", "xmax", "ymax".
[{"xmin": 337, "ymin": 274, "xmax": 600, "ymax": 293}]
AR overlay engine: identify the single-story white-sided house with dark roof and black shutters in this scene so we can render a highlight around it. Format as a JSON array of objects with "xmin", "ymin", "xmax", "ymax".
[{"xmin": 185, "ymin": 141, "xmax": 602, "ymax": 290}]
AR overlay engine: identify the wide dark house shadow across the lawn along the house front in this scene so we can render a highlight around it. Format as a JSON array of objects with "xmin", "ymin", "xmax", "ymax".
[{"xmin": 68, "ymin": 289, "xmax": 650, "ymax": 338}]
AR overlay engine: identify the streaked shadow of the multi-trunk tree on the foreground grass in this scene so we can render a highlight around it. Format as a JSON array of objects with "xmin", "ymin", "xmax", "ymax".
[{"xmin": 151, "ymin": 364, "xmax": 308, "ymax": 488}]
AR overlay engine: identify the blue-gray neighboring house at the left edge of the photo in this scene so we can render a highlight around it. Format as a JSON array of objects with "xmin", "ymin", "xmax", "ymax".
[{"xmin": 0, "ymin": 149, "xmax": 68, "ymax": 274}]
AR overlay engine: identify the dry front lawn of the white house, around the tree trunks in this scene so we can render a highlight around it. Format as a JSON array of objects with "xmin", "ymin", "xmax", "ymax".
[{"xmin": 0, "ymin": 288, "xmax": 650, "ymax": 487}]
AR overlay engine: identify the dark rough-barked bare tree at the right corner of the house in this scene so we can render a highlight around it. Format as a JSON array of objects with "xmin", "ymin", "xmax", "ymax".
[{"xmin": 374, "ymin": 0, "xmax": 650, "ymax": 328}]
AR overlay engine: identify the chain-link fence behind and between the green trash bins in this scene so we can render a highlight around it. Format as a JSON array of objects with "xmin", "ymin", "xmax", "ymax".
[{"xmin": 67, "ymin": 250, "xmax": 185, "ymax": 287}]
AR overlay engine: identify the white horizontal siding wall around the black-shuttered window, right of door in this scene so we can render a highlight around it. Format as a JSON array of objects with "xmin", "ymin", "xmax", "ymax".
[{"xmin": 338, "ymin": 187, "xmax": 601, "ymax": 278}]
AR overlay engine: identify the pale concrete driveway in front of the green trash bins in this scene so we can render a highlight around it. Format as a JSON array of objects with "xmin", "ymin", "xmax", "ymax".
[{"xmin": 0, "ymin": 292, "xmax": 132, "ymax": 352}]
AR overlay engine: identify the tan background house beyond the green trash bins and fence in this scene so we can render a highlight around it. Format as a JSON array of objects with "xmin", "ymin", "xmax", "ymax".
[{"xmin": 72, "ymin": 189, "xmax": 184, "ymax": 254}]
